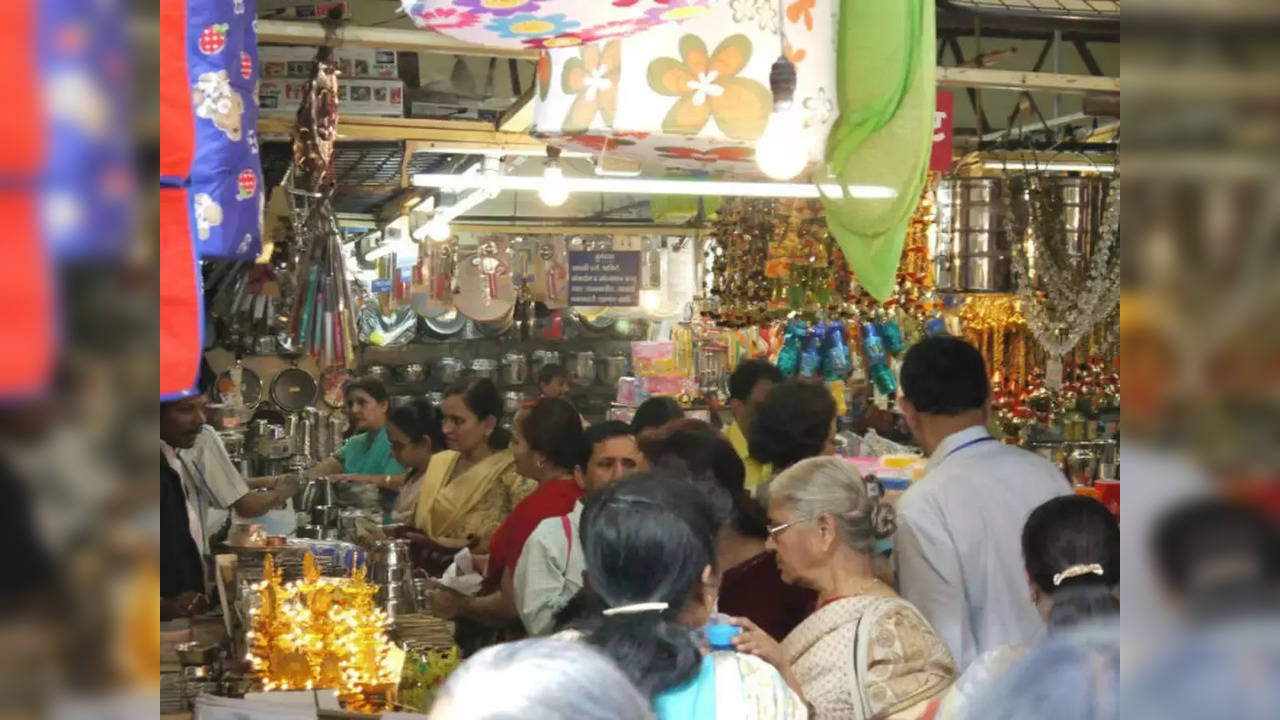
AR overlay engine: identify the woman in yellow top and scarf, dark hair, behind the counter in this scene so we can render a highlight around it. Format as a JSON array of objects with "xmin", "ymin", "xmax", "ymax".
[{"xmin": 411, "ymin": 378, "xmax": 538, "ymax": 575}]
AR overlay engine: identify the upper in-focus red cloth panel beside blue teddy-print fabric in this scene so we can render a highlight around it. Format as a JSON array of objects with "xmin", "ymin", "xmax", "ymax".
[{"xmin": 160, "ymin": 0, "xmax": 196, "ymax": 178}]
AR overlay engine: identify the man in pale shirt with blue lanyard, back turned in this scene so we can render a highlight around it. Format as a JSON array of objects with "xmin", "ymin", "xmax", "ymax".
[{"xmin": 893, "ymin": 337, "xmax": 1071, "ymax": 673}]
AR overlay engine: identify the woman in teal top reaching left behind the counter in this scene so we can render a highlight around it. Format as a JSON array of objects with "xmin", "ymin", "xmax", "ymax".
[{"xmin": 307, "ymin": 378, "xmax": 404, "ymax": 512}]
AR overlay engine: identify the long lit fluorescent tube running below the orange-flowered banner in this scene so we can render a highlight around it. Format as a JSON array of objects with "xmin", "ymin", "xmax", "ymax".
[{"xmin": 413, "ymin": 173, "xmax": 897, "ymax": 200}]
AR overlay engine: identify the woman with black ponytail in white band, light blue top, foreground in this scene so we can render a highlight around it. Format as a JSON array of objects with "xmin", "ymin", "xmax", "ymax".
[{"xmin": 581, "ymin": 466, "xmax": 808, "ymax": 720}]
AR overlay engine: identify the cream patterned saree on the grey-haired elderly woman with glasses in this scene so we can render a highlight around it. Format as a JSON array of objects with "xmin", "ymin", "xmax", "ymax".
[{"xmin": 782, "ymin": 596, "xmax": 955, "ymax": 720}]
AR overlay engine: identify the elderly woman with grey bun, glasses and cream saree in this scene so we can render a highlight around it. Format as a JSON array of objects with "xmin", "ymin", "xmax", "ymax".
[{"xmin": 735, "ymin": 457, "xmax": 955, "ymax": 720}]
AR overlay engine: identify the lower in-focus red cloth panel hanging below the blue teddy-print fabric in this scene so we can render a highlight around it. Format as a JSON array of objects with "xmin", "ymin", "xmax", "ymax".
[{"xmin": 160, "ymin": 187, "xmax": 202, "ymax": 398}]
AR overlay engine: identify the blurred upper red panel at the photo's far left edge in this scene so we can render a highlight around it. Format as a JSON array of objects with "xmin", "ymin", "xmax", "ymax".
[{"xmin": 0, "ymin": 3, "xmax": 45, "ymax": 174}]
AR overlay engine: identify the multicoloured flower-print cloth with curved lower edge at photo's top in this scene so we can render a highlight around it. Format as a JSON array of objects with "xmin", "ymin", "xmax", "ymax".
[{"xmin": 401, "ymin": 0, "xmax": 728, "ymax": 50}]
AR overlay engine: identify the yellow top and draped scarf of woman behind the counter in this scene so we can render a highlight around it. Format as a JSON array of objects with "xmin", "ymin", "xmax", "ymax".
[{"xmin": 413, "ymin": 450, "xmax": 538, "ymax": 543}]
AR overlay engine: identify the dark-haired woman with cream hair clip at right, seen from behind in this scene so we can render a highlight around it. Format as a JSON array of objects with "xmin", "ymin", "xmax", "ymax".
[{"xmin": 937, "ymin": 495, "xmax": 1120, "ymax": 720}]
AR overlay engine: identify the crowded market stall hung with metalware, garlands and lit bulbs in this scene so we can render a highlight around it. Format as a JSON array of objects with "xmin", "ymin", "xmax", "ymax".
[{"xmin": 161, "ymin": 0, "xmax": 1120, "ymax": 717}]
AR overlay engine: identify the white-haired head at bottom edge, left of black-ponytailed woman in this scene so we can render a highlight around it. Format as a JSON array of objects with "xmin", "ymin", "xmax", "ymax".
[{"xmin": 429, "ymin": 638, "xmax": 654, "ymax": 720}]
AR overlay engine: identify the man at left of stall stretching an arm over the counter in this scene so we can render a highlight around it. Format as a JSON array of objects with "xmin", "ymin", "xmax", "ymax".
[{"xmin": 160, "ymin": 396, "xmax": 297, "ymax": 619}]
